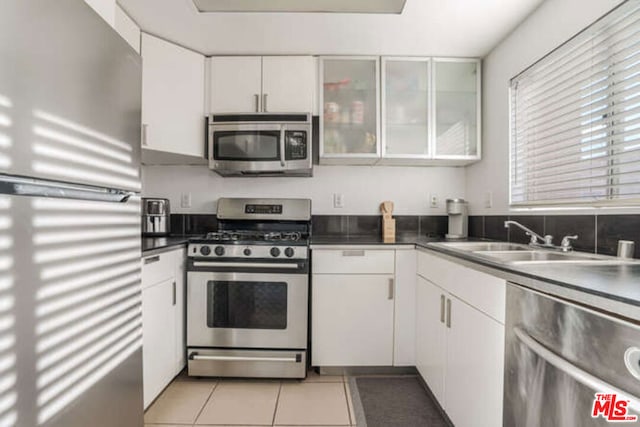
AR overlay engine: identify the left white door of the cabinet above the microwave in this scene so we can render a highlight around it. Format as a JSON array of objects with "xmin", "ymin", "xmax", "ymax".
[{"xmin": 210, "ymin": 56, "xmax": 262, "ymax": 113}]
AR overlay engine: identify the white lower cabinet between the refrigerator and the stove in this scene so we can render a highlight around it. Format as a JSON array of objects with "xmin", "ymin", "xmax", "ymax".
[{"xmin": 142, "ymin": 249, "xmax": 186, "ymax": 408}]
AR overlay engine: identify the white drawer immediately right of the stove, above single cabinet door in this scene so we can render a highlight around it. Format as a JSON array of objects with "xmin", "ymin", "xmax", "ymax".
[{"xmin": 312, "ymin": 248, "xmax": 395, "ymax": 274}]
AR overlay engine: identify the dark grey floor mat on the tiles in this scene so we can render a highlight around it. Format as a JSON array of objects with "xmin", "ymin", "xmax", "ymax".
[{"xmin": 354, "ymin": 376, "xmax": 448, "ymax": 427}]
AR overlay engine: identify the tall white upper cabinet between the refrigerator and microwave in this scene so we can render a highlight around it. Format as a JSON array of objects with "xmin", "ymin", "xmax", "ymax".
[{"xmin": 141, "ymin": 33, "xmax": 205, "ymax": 162}]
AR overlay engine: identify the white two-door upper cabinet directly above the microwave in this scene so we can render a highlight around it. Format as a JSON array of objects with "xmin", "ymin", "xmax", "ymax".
[{"xmin": 209, "ymin": 56, "xmax": 315, "ymax": 113}]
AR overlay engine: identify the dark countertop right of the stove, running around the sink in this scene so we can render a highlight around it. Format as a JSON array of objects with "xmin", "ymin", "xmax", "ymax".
[{"xmin": 311, "ymin": 236, "xmax": 640, "ymax": 321}]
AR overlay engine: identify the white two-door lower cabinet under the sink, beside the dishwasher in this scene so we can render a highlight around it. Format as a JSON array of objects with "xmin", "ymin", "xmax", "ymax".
[{"xmin": 416, "ymin": 251, "xmax": 506, "ymax": 427}]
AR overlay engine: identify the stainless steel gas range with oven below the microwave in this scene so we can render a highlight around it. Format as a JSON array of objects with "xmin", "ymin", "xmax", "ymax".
[{"xmin": 187, "ymin": 198, "xmax": 311, "ymax": 378}]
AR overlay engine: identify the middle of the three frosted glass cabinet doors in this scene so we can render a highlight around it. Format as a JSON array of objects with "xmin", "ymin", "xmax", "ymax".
[{"xmin": 382, "ymin": 58, "xmax": 430, "ymax": 159}]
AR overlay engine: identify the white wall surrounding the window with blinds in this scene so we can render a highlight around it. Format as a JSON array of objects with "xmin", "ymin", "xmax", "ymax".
[{"xmin": 466, "ymin": 0, "xmax": 631, "ymax": 215}]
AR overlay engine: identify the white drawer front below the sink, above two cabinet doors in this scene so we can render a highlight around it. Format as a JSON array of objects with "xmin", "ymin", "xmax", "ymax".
[{"xmin": 418, "ymin": 251, "xmax": 507, "ymax": 324}]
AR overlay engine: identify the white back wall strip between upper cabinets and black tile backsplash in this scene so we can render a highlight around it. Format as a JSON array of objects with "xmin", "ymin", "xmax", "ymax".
[{"xmin": 142, "ymin": 166, "xmax": 465, "ymax": 215}]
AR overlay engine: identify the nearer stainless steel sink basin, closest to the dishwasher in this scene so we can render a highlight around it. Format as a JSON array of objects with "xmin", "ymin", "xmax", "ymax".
[{"xmin": 475, "ymin": 250, "xmax": 632, "ymax": 264}]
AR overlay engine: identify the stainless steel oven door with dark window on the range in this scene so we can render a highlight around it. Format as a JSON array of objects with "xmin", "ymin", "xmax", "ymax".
[{"xmin": 187, "ymin": 271, "xmax": 309, "ymax": 349}]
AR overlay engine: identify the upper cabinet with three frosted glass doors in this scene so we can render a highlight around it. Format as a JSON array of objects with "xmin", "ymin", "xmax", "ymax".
[{"xmin": 319, "ymin": 56, "xmax": 481, "ymax": 166}]
